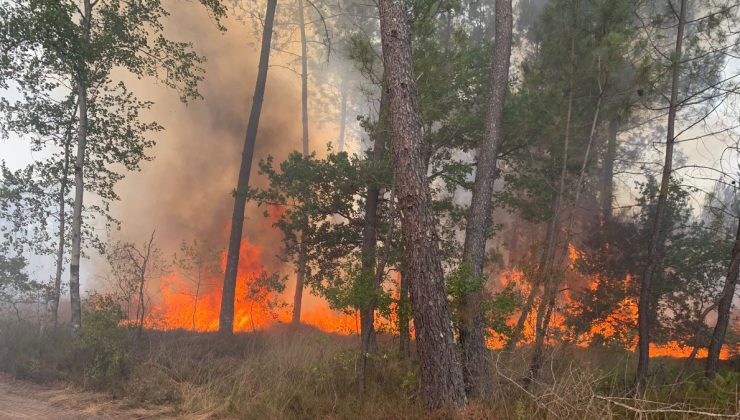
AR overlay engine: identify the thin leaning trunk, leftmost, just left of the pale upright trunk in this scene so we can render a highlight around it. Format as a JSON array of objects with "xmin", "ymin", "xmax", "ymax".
[{"xmin": 51, "ymin": 99, "xmax": 79, "ymax": 331}]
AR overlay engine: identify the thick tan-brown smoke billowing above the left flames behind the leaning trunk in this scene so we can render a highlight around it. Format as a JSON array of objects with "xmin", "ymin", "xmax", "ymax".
[{"xmin": 107, "ymin": 1, "xmax": 352, "ymax": 274}]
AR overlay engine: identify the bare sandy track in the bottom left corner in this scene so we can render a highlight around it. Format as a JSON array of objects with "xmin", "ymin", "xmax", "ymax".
[{"xmin": 0, "ymin": 375, "xmax": 177, "ymax": 420}]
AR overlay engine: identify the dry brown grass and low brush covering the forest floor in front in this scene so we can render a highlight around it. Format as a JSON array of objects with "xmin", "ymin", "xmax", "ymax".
[{"xmin": 0, "ymin": 316, "xmax": 740, "ymax": 419}]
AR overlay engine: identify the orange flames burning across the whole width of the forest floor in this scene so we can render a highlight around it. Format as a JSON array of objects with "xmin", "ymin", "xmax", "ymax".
[{"xmin": 137, "ymin": 241, "xmax": 740, "ymax": 360}]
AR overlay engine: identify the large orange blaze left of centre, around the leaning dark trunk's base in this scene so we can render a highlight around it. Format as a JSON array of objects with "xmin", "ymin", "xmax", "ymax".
[{"xmin": 145, "ymin": 240, "xmax": 357, "ymax": 334}]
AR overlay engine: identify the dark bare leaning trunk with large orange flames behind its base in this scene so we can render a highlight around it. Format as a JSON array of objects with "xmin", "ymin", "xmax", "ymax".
[{"xmin": 218, "ymin": 0, "xmax": 277, "ymax": 334}]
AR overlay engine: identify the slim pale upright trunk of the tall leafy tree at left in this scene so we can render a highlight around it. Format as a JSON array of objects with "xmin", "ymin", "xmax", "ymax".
[{"xmin": 69, "ymin": 0, "xmax": 92, "ymax": 332}]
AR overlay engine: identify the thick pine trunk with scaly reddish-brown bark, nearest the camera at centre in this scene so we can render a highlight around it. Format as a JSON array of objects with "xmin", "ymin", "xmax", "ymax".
[{"xmin": 379, "ymin": 0, "xmax": 466, "ymax": 408}]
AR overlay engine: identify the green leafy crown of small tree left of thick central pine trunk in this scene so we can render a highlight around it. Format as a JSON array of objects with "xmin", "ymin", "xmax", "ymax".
[{"xmin": 247, "ymin": 149, "xmax": 398, "ymax": 309}]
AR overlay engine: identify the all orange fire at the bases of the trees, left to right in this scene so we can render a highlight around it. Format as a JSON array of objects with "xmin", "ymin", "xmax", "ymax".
[{"xmin": 137, "ymin": 241, "xmax": 740, "ymax": 360}]
